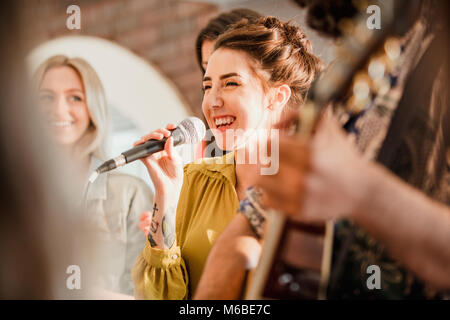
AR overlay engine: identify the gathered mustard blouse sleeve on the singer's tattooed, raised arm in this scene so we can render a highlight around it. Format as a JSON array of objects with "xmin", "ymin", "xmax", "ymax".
[{"xmin": 132, "ymin": 170, "xmax": 189, "ymax": 300}]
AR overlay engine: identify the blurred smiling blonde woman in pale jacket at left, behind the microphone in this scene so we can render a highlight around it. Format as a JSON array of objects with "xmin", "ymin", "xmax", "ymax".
[{"xmin": 34, "ymin": 55, "xmax": 153, "ymax": 295}]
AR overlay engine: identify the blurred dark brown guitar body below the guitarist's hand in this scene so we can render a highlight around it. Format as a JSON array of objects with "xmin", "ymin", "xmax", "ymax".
[{"xmin": 245, "ymin": 213, "xmax": 334, "ymax": 300}]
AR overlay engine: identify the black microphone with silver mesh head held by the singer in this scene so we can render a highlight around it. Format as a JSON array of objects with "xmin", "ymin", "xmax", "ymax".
[{"xmin": 89, "ymin": 117, "xmax": 206, "ymax": 183}]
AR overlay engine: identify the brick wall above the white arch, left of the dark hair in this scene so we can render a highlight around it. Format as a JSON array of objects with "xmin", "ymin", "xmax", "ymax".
[{"xmin": 30, "ymin": 0, "xmax": 219, "ymax": 116}]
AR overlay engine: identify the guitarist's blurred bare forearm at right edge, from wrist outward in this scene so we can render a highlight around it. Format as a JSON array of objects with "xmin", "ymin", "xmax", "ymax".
[{"xmin": 353, "ymin": 164, "xmax": 450, "ymax": 288}]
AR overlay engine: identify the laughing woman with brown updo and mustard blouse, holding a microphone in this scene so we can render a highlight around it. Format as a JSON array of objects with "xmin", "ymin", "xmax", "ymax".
[{"xmin": 133, "ymin": 17, "xmax": 320, "ymax": 299}]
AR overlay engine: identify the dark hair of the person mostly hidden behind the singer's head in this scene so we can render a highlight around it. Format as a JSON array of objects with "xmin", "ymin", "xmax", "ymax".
[{"xmin": 195, "ymin": 9, "xmax": 262, "ymax": 73}]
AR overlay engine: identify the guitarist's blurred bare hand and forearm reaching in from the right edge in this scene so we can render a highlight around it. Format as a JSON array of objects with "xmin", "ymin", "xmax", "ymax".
[{"xmin": 244, "ymin": 107, "xmax": 450, "ymax": 289}]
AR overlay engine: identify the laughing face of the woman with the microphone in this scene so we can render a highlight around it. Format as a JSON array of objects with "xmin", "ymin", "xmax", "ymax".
[{"xmin": 202, "ymin": 48, "xmax": 269, "ymax": 150}]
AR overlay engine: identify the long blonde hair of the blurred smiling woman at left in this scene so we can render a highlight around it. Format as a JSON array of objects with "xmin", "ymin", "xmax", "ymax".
[{"xmin": 33, "ymin": 55, "xmax": 108, "ymax": 160}]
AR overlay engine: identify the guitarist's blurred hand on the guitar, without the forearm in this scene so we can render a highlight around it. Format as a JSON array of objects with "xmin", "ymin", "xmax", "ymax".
[{"xmin": 248, "ymin": 113, "xmax": 370, "ymax": 221}]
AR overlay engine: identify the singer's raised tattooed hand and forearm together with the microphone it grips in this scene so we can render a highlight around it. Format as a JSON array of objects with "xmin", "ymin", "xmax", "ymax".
[{"xmin": 89, "ymin": 117, "xmax": 206, "ymax": 249}]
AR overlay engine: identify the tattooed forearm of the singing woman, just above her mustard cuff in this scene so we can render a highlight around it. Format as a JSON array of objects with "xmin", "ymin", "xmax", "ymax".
[{"xmin": 148, "ymin": 194, "xmax": 176, "ymax": 250}]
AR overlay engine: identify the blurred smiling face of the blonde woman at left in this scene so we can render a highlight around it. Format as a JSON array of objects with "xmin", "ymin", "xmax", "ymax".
[{"xmin": 39, "ymin": 66, "xmax": 90, "ymax": 146}]
